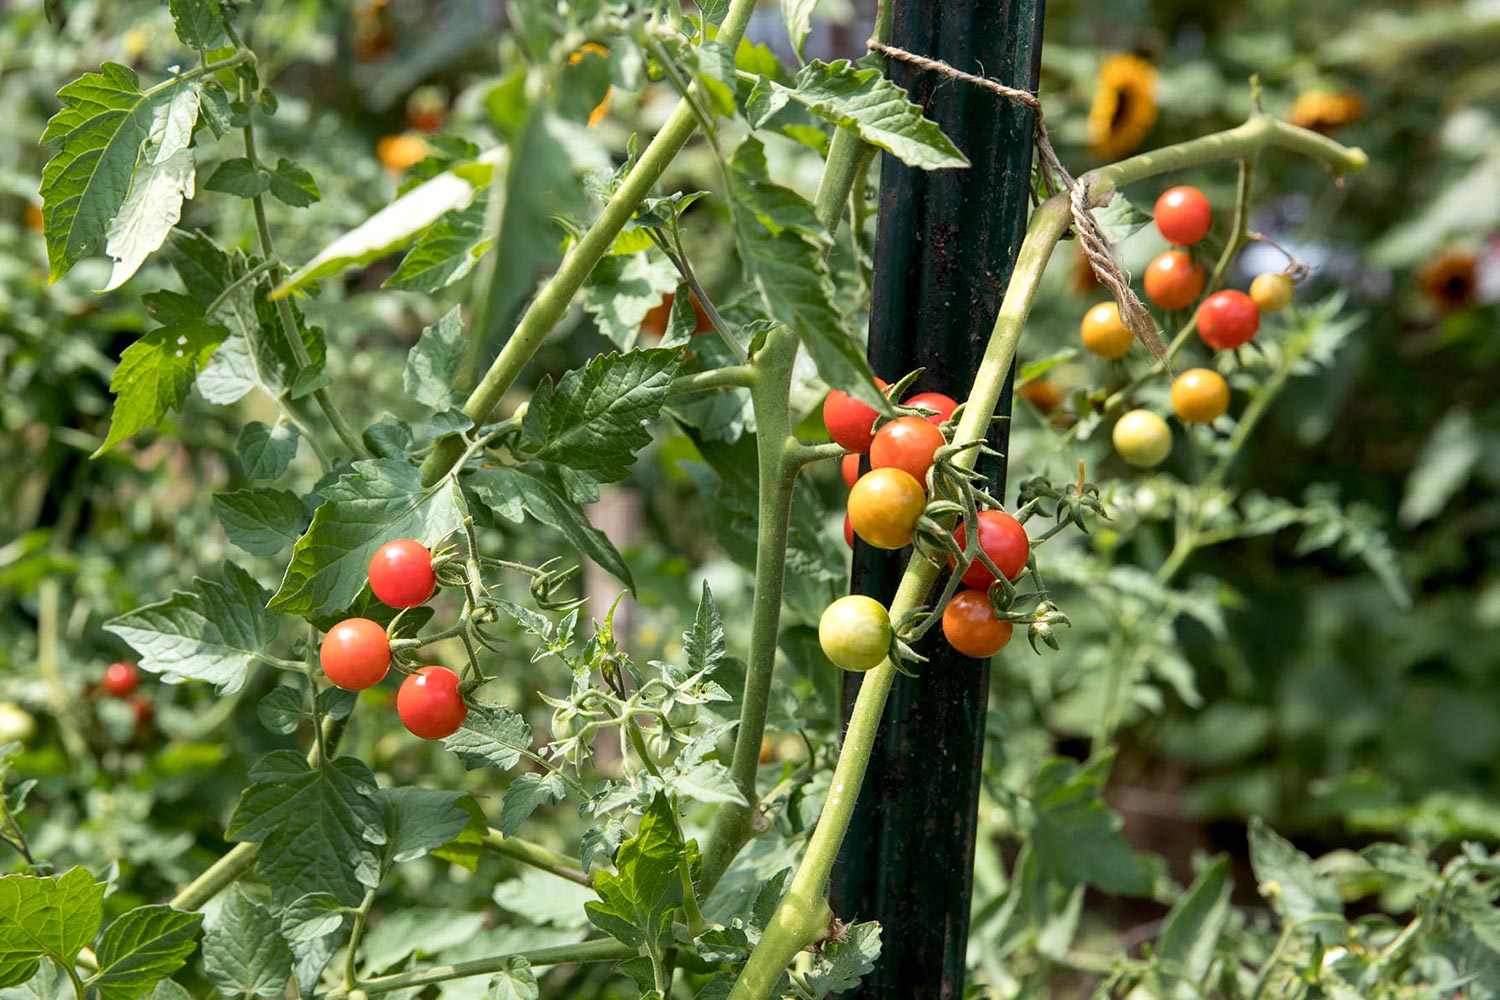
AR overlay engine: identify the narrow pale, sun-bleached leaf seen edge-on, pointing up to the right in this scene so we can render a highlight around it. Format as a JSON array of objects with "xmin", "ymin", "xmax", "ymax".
[{"xmin": 273, "ymin": 148, "xmax": 507, "ymax": 298}]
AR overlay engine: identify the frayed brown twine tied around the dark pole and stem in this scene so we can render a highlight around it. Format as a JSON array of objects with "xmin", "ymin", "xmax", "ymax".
[{"xmin": 867, "ymin": 39, "xmax": 1169, "ymax": 367}]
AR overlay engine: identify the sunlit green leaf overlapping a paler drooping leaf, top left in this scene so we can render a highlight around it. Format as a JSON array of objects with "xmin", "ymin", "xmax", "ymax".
[{"xmin": 42, "ymin": 63, "xmax": 192, "ymax": 282}]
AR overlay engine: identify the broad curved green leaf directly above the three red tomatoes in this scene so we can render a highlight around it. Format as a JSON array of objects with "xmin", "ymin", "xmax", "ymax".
[{"xmin": 270, "ymin": 459, "xmax": 464, "ymax": 618}]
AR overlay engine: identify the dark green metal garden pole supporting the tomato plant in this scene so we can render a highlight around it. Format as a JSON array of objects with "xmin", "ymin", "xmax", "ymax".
[{"xmin": 833, "ymin": 0, "xmax": 1044, "ymax": 1000}]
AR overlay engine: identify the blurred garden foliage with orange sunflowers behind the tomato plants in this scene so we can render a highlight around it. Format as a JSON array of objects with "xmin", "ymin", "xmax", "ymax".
[{"xmin": 0, "ymin": 0, "xmax": 1500, "ymax": 996}]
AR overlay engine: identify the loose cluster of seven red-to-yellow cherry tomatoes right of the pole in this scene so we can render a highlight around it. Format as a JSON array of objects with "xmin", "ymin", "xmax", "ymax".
[{"xmin": 1079, "ymin": 184, "xmax": 1292, "ymax": 468}]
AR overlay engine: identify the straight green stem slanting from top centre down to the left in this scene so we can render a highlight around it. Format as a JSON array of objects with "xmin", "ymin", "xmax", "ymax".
[{"xmin": 422, "ymin": 0, "xmax": 756, "ymax": 483}]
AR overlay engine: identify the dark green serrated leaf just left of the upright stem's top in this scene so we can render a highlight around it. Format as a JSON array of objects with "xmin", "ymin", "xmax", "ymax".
[{"xmin": 521, "ymin": 348, "xmax": 683, "ymax": 483}]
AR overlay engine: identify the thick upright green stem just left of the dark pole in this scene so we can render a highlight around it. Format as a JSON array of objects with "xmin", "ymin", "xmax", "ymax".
[{"xmin": 702, "ymin": 327, "xmax": 797, "ymax": 894}]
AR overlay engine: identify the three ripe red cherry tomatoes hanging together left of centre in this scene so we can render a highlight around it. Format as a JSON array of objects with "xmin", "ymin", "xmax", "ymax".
[{"xmin": 318, "ymin": 538, "xmax": 468, "ymax": 739}]
